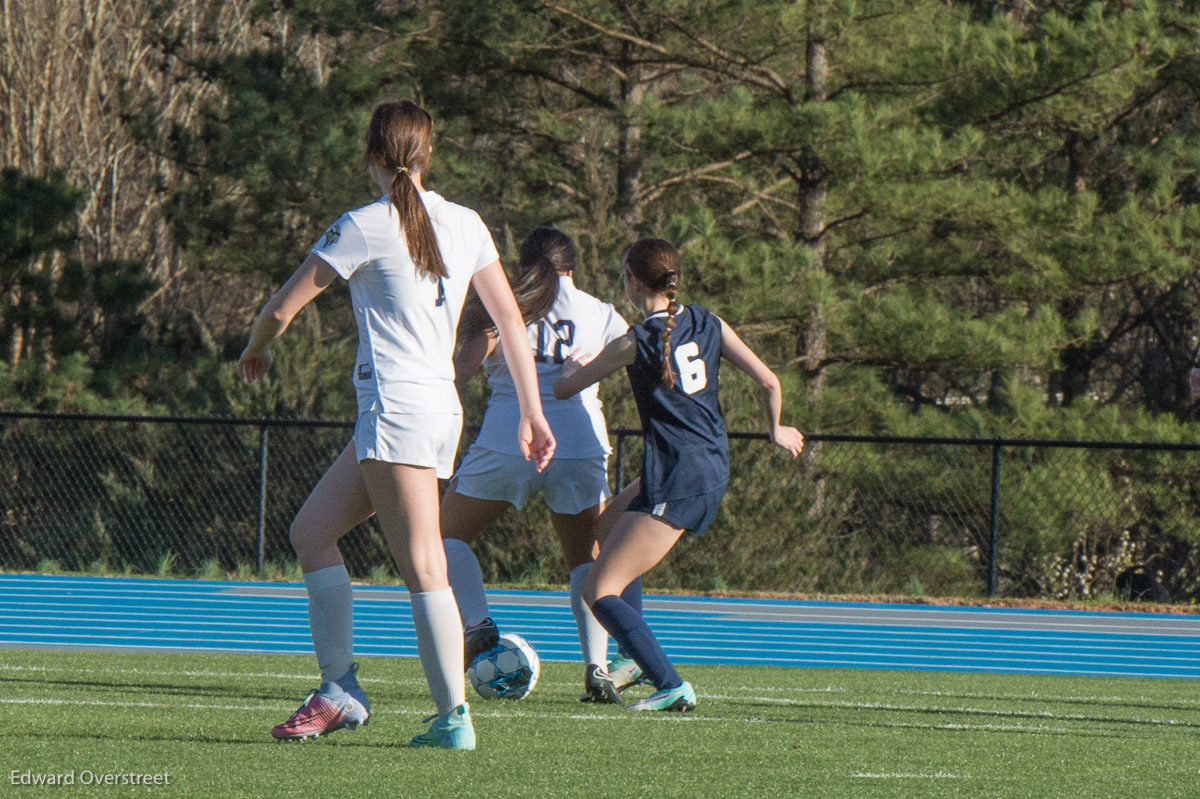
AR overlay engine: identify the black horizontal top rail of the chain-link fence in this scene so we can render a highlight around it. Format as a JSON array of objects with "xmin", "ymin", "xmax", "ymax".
[{"xmin": 7, "ymin": 409, "xmax": 1200, "ymax": 452}]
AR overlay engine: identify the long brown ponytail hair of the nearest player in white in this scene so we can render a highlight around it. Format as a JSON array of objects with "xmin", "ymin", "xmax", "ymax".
[{"xmin": 366, "ymin": 100, "xmax": 449, "ymax": 277}]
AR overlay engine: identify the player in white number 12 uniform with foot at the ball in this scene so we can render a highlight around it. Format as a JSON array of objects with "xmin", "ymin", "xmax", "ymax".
[{"xmin": 442, "ymin": 227, "xmax": 629, "ymax": 702}]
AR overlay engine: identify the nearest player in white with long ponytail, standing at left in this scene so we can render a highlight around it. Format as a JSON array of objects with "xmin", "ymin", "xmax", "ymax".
[{"xmin": 238, "ymin": 102, "xmax": 554, "ymax": 750}]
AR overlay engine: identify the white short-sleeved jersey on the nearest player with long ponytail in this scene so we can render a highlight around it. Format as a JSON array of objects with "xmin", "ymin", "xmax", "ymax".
[{"xmin": 312, "ymin": 192, "xmax": 499, "ymax": 412}]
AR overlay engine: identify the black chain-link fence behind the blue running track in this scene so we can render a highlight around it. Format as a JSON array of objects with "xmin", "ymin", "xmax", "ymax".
[{"xmin": 0, "ymin": 411, "xmax": 1200, "ymax": 601}]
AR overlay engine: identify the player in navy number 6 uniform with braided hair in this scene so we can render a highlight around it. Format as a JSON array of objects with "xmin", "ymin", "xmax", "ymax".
[{"xmin": 554, "ymin": 239, "xmax": 804, "ymax": 711}]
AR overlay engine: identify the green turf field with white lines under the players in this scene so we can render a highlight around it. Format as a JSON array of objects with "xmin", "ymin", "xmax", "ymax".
[{"xmin": 0, "ymin": 649, "xmax": 1200, "ymax": 799}]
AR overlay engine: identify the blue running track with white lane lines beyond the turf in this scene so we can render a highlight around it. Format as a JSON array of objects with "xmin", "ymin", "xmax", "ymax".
[{"xmin": 0, "ymin": 575, "xmax": 1200, "ymax": 678}]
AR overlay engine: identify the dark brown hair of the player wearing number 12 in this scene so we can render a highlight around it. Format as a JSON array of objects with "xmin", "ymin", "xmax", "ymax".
[{"xmin": 458, "ymin": 227, "xmax": 575, "ymax": 338}]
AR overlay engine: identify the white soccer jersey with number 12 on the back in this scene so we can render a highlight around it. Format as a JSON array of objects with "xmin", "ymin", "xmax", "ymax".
[{"xmin": 475, "ymin": 275, "xmax": 629, "ymax": 458}]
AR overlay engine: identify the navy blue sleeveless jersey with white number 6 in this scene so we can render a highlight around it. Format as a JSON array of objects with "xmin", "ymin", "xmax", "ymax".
[{"xmin": 626, "ymin": 305, "xmax": 730, "ymax": 503}]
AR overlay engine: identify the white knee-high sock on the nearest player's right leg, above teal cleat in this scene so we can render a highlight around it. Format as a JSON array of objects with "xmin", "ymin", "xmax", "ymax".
[{"xmin": 413, "ymin": 588, "xmax": 467, "ymax": 714}]
